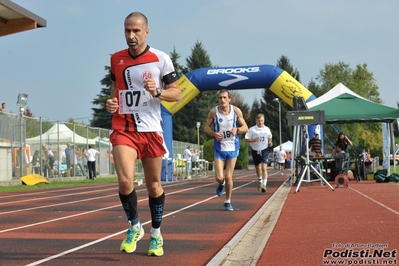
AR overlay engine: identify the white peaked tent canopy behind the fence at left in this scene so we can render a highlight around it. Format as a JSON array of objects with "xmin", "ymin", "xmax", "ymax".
[{"xmin": 26, "ymin": 124, "xmax": 96, "ymax": 144}]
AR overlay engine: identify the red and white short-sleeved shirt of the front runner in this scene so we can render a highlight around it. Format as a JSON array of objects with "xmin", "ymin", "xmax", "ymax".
[{"xmin": 111, "ymin": 46, "xmax": 177, "ymax": 132}]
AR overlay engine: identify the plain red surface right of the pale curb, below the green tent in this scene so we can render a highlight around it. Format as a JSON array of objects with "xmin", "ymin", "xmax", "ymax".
[{"xmin": 257, "ymin": 181, "xmax": 399, "ymax": 266}]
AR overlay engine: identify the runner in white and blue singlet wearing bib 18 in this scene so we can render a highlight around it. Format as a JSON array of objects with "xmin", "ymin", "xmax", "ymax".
[{"xmin": 204, "ymin": 89, "xmax": 248, "ymax": 211}]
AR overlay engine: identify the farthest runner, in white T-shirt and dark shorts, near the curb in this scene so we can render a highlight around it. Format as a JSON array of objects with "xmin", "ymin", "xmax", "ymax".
[{"xmin": 245, "ymin": 114, "xmax": 273, "ymax": 193}]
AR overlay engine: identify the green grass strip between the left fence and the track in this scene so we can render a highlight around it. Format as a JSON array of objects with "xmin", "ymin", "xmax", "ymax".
[{"xmin": 0, "ymin": 176, "xmax": 118, "ymax": 193}]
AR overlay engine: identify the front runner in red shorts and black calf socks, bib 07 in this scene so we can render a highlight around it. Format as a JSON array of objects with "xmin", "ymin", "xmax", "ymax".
[{"xmin": 106, "ymin": 12, "xmax": 181, "ymax": 256}]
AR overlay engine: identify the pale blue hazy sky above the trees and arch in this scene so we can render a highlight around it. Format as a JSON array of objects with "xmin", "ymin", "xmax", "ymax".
[{"xmin": 0, "ymin": 0, "xmax": 399, "ymax": 123}]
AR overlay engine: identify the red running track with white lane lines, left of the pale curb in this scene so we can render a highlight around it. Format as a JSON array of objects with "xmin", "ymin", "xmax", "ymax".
[{"xmin": 0, "ymin": 171, "xmax": 285, "ymax": 265}]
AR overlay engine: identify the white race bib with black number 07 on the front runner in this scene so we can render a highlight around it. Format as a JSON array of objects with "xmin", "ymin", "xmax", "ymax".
[{"xmin": 119, "ymin": 90, "xmax": 150, "ymax": 114}]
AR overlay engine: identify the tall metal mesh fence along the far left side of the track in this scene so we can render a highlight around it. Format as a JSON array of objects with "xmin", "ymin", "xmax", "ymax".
[{"xmin": 0, "ymin": 113, "xmax": 213, "ymax": 181}]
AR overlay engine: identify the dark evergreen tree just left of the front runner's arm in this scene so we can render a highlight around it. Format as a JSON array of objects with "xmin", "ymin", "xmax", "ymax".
[{"xmin": 90, "ymin": 66, "xmax": 112, "ymax": 128}]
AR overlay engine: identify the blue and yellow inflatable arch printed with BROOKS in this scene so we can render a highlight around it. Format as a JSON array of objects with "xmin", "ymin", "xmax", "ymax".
[{"xmin": 161, "ymin": 65, "xmax": 322, "ymax": 181}]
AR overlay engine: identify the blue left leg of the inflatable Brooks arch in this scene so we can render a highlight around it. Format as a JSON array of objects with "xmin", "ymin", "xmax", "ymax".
[{"xmin": 161, "ymin": 105, "xmax": 173, "ymax": 181}]
